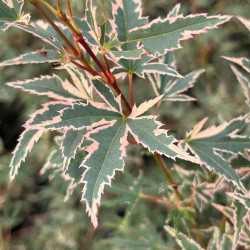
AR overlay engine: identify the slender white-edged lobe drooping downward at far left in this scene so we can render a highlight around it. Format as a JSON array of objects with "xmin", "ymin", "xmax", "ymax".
[{"xmin": 10, "ymin": 129, "xmax": 44, "ymax": 180}]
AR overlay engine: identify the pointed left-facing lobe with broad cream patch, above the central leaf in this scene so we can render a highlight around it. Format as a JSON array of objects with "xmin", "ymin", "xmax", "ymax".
[{"xmin": 6, "ymin": 74, "xmax": 86, "ymax": 101}]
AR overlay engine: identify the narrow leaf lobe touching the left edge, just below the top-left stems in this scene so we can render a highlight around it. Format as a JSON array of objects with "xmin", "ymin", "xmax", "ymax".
[{"xmin": 0, "ymin": 50, "xmax": 61, "ymax": 67}]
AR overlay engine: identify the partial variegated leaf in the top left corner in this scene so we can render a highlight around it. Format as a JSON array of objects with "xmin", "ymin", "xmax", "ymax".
[{"xmin": 0, "ymin": 0, "xmax": 30, "ymax": 31}]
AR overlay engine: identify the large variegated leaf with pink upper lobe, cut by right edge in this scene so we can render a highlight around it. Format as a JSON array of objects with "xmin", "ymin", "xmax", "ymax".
[{"xmin": 185, "ymin": 116, "xmax": 250, "ymax": 192}]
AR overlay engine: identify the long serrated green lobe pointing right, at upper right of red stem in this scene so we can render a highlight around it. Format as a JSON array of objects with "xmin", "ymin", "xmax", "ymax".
[{"xmin": 112, "ymin": 14, "xmax": 232, "ymax": 55}]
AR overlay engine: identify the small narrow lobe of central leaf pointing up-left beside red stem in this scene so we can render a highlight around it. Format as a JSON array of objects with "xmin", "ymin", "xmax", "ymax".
[{"xmin": 92, "ymin": 79, "xmax": 120, "ymax": 112}]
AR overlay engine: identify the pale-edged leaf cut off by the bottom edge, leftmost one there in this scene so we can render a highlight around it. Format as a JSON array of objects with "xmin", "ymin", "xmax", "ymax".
[{"xmin": 164, "ymin": 225, "xmax": 203, "ymax": 250}]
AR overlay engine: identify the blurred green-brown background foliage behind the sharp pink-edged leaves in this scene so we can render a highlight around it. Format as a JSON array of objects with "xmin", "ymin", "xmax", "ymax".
[{"xmin": 0, "ymin": 0, "xmax": 250, "ymax": 250}]
